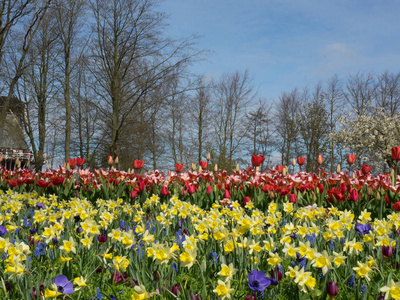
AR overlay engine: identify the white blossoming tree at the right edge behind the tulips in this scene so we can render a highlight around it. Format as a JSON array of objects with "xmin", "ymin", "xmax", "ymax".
[{"xmin": 330, "ymin": 109, "xmax": 400, "ymax": 170}]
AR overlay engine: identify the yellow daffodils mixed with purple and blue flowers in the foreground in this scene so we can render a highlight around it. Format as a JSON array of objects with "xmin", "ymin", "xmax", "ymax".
[{"xmin": 0, "ymin": 190, "xmax": 400, "ymax": 300}]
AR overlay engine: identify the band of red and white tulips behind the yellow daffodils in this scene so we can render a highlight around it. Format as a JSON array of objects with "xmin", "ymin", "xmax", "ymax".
[{"xmin": 0, "ymin": 155, "xmax": 400, "ymax": 218}]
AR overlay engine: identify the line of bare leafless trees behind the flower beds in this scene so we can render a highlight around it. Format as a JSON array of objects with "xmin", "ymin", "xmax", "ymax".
[{"xmin": 0, "ymin": 0, "xmax": 400, "ymax": 172}]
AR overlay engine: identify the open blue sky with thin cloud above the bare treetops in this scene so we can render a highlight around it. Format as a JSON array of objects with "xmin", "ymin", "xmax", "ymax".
[{"xmin": 159, "ymin": 0, "xmax": 400, "ymax": 99}]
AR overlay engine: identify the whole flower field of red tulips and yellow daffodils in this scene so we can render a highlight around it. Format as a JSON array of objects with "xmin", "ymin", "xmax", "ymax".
[{"xmin": 0, "ymin": 158, "xmax": 400, "ymax": 300}]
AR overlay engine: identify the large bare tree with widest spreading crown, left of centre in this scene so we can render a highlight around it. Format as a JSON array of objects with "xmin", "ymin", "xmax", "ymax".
[{"xmin": 91, "ymin": 0, "xmax": 195, "ymax": 165}]
